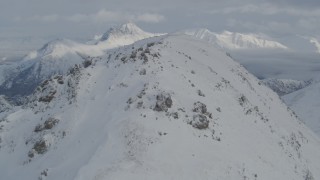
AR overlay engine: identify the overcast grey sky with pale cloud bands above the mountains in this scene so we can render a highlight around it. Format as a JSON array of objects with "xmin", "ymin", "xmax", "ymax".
[{"xmin": 0, "ymin": 0, "xmax": 320, "ymax": 38}]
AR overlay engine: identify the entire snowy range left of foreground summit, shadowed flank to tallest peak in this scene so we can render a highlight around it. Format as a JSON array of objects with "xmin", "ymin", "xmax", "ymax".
[{"xmin": 0, "ymin": 23, "xmax": 162, "ymax": 99}]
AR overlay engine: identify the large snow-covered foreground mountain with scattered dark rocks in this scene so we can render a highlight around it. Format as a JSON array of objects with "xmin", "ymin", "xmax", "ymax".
[{"xmin": 0, "ymin": 34, "xmax": 320, "ymax": 180}]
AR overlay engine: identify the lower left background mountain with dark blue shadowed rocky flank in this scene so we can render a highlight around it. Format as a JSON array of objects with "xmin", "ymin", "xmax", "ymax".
[{"xmin": 0, "ymin": 40, "xmax": 94, "ymax": 100}]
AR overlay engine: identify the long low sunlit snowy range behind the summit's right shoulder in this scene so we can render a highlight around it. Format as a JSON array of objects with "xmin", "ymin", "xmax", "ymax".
[{"xmin": 185, "ymin": 29, "xmax": 288, "ymax": 50}]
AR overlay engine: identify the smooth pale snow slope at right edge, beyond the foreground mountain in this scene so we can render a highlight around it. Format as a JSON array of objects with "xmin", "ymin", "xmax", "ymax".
[{"xmin": 282, "ymin": 82, "xmax": 320, "ymax": 137}]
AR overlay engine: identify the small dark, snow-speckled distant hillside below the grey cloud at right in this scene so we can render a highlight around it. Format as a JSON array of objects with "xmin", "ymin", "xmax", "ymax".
[{"xmin": 261, "ymin": 78, "xmax": 311, "ymax": 96}]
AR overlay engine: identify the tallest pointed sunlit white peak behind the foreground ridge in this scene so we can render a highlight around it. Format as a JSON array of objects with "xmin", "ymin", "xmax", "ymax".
[{"xmin": 95, "ymin": 23, "xmax": 162, "ymax": 49}]
